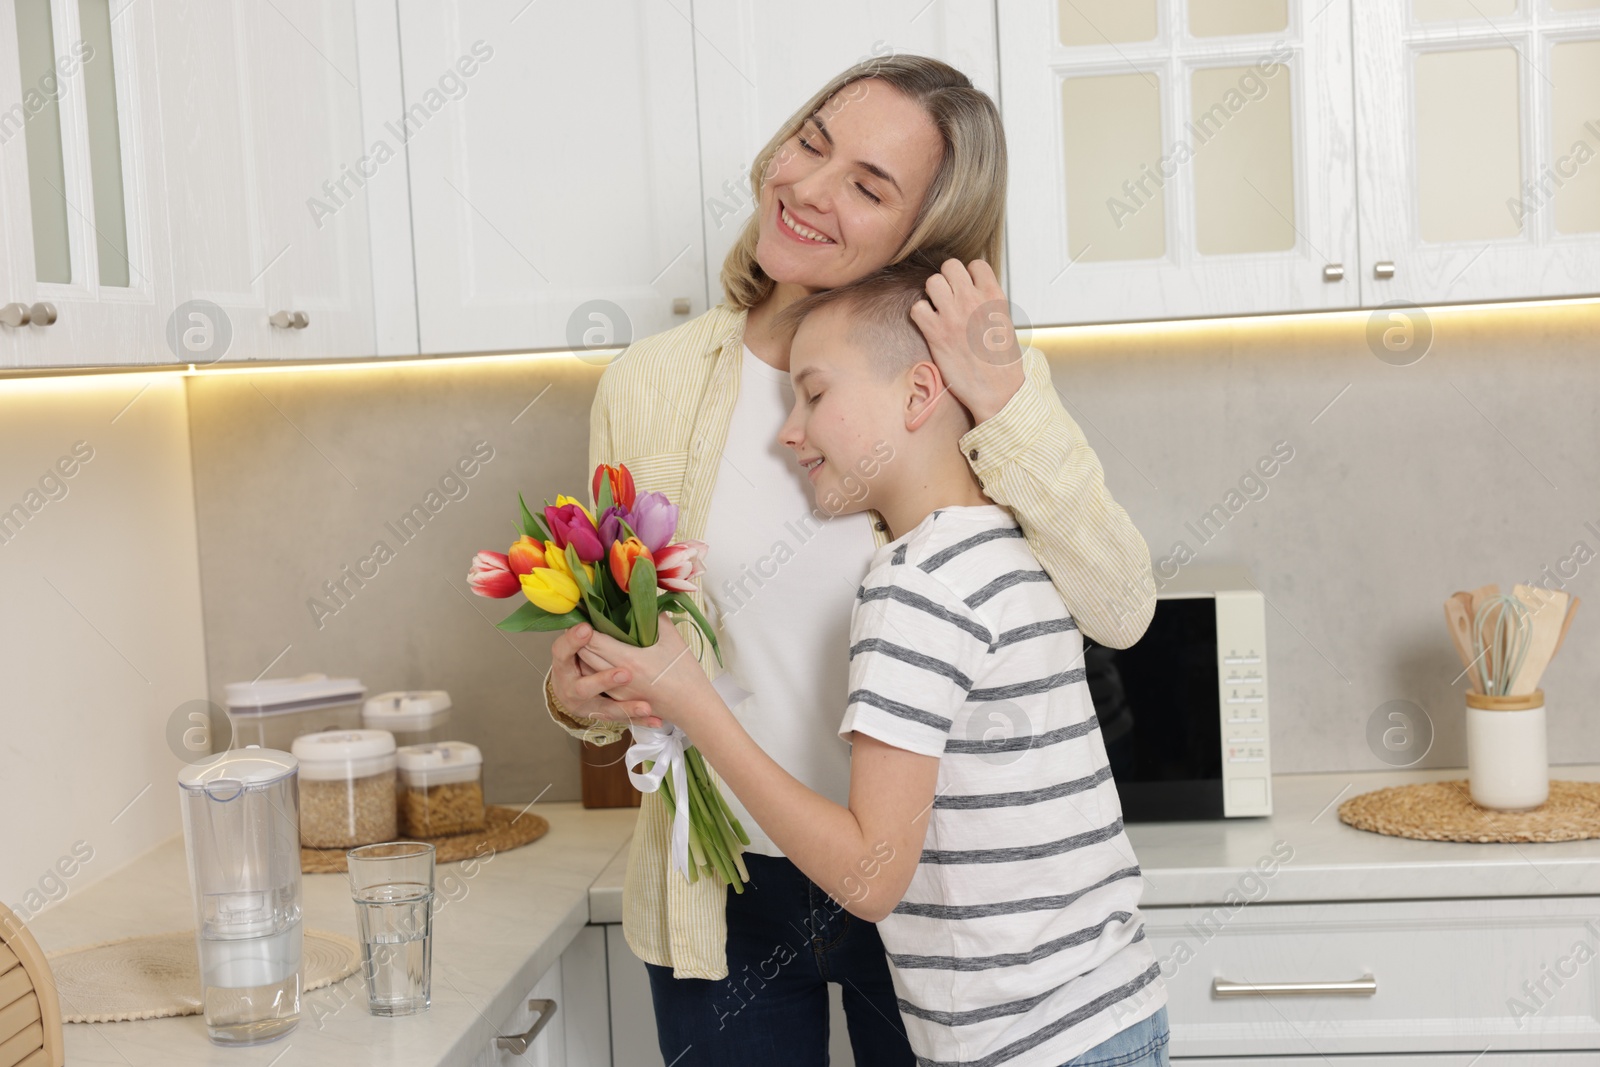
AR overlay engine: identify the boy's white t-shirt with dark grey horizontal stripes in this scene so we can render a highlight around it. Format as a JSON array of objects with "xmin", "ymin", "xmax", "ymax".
[{"xmin": 838, "ymin": 504, "xmax": 1166, "ymax": 1067}]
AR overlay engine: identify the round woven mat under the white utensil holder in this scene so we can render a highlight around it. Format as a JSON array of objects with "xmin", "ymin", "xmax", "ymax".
[{"xmin": 1339, "ymin": 777, "xmax": 1600, "ymax": 843}]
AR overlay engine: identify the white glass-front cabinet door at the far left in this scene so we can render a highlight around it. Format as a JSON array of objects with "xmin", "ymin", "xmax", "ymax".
[{"xmin": 0, "ymin": 0, "xmax": 171, "ymax": 366}]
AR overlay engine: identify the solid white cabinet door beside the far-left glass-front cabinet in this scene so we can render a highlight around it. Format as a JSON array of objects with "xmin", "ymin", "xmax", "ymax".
[{"xmin": 149, "ymin": 0, "xmax": 374, "ymax": 363}]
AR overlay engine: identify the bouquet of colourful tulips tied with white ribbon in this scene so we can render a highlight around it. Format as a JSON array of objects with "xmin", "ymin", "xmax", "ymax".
[{"xmin": 467, "ymin": 464, "xmax": 750, "ymax": 893}]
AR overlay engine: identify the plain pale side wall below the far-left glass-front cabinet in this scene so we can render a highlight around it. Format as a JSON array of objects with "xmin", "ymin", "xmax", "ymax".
[{"xmin": 0, "ymin": 374, "xmax": 206, "ymax": 920}]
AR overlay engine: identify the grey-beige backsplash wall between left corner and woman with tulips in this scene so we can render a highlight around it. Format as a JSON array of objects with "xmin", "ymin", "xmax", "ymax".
[{"xmin": 189, "ymin": 355, "xmax": 604, "ymax": 803}]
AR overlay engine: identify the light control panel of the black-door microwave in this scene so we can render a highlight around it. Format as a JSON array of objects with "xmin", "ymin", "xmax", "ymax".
[{"xmin": 1216, "ymin": 587, "xmax": 1272, "ymax": 817}]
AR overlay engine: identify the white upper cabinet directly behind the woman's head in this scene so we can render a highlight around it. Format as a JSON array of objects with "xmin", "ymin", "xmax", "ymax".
[{"xmin": 694, "ymin": 0, "xmax": 992, "ymax": 302}]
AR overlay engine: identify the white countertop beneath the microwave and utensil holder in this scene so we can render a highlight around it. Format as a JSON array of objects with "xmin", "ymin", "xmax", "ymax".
[{"xmin": 589, "ymin": 763, "xmax": 1600, "ymax": 923}]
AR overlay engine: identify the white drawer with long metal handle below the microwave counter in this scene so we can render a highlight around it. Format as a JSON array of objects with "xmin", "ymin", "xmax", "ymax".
[{"xmin": 1144, "ymin": 897, "xmax": 1600, "ymax": 1067}]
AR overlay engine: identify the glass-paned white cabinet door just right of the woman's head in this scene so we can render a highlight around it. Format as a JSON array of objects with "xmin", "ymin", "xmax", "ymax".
[{"xmin": 998, "ymin": 0, "xmax": 1360, "ymax": 325}]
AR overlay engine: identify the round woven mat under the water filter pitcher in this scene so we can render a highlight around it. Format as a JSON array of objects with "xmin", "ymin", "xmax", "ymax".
[{"xmin": 50, "ymin": 929, "xmax": 362, "ymax": 1022}]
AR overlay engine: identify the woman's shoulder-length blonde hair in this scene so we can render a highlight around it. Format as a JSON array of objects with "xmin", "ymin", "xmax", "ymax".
[{"xmin": 722, "ymin": 56, "xmax": 1006, "ymax": 309}]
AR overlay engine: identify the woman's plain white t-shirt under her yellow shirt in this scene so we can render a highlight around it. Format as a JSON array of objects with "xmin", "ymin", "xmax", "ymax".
[{"xmin": 701, "ymin": 346, "xmax": 877, "ymax": 856}]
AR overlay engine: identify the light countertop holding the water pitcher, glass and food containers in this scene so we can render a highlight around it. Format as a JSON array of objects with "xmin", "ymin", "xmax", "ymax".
[{"xmin": 29, "ymin": 803, "xmax": 638, "ymax": 1067}]
